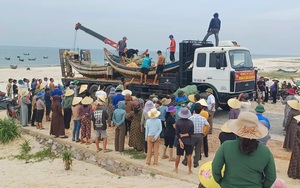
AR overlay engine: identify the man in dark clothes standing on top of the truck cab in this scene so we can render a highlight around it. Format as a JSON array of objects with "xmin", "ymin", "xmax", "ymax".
[{"xmin": 202, "ymin": 13, "xmax": 221, "ymax": 46}]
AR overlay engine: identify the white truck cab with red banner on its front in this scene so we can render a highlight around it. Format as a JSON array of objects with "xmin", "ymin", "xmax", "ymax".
[{"xmin": 192, "ymin": 41, "xmax": 256, "ymax": 109}]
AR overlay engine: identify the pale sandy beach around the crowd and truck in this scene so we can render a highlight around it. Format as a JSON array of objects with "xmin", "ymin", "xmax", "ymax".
[{"xmin": 0, "ymin": 58, "xmax": 300, "ymax": 187}]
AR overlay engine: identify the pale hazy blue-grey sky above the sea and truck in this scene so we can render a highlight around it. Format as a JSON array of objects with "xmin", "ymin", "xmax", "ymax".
[{"xmin": 0, "ymin": 0, "xmax": 300, "ymax": 55}]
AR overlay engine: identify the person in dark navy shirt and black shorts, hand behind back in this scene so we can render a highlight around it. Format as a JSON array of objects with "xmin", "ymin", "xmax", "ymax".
[{"xmin": 174, "ymin": 107, "xmax": 194, "ymax": 174}]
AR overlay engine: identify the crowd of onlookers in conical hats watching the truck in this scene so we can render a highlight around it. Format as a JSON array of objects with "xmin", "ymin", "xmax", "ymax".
[{"xmin": 2, "ymin": 74, "xmax": 300, "ymax": 186}]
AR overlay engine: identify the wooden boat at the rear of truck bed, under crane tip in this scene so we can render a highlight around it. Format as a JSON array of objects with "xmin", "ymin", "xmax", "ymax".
[{"xmin": 66, "ymin": 58, "xmax": 107, "ymax": 78}]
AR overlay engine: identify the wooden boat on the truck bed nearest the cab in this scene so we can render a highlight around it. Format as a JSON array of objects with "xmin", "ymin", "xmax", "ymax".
[{"xmin": 104, "ymin": 48, "xmax": 184, "ymax": 77}]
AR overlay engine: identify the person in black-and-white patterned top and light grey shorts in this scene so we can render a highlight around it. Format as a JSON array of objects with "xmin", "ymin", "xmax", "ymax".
[{"xmin": 92, "ymin": 101, "xmax": 109, "ymax": 152}]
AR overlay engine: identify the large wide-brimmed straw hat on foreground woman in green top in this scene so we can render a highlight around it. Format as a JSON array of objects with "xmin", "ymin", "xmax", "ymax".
[{"xmin": 227, "ymin": 112, "xmax": 268, "ymax": 139}]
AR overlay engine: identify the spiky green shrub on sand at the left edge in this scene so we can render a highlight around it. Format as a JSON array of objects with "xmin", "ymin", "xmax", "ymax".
[{"xmin": 0, "ymin": 118, "xmax": 21, "ymax": 144}]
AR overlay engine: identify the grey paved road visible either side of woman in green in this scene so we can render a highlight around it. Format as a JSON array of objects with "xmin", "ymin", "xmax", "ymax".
[{"xmin": 214, "ymin": 110, "xmax": 284, "ymax": 141}]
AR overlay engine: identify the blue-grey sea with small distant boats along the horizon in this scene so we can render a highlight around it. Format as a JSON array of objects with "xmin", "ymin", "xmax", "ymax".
[{"xmin": 0, "ymin": 46, "xmax": 299, "ymax": 68}]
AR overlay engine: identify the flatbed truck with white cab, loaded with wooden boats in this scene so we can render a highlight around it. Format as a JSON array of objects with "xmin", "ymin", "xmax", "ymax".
[{"xmin": 60, "ymin": 23, "xmax": 257, "ymax": 110}]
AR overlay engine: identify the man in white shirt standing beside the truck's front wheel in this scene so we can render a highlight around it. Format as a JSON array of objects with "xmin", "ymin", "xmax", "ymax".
[{"xmin": 205, "ymin": 88, "xmax": 216, "ymax": 134}]
